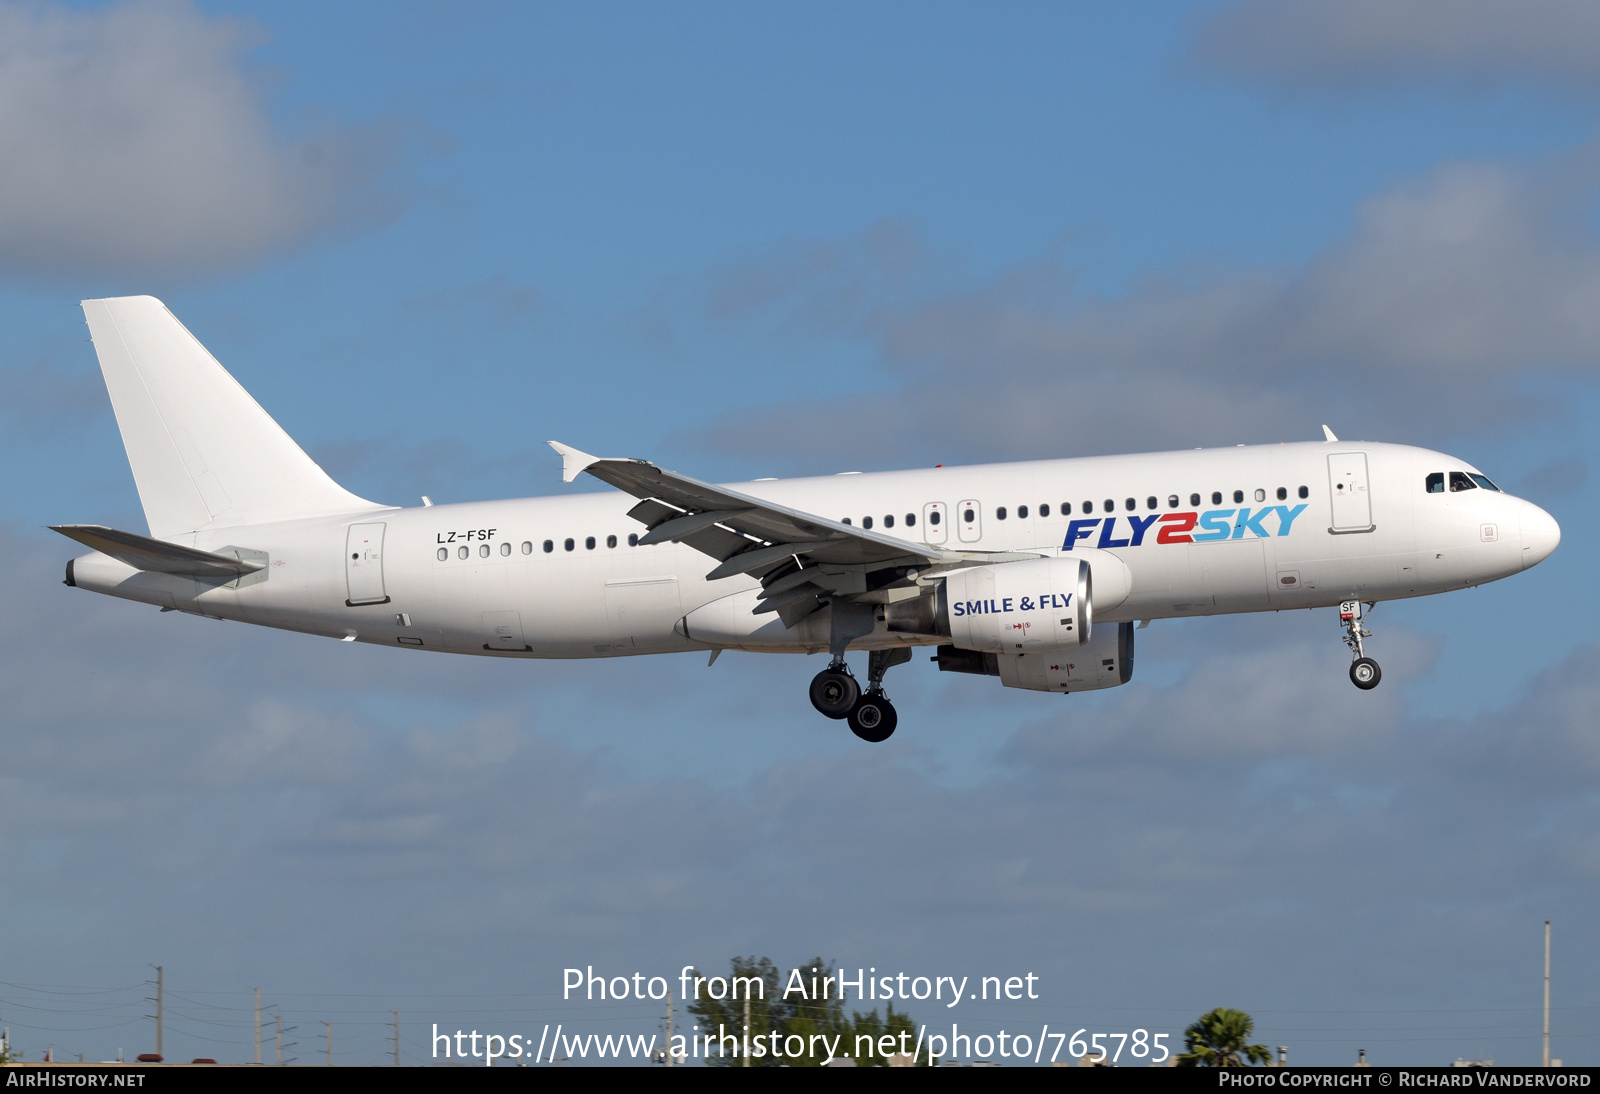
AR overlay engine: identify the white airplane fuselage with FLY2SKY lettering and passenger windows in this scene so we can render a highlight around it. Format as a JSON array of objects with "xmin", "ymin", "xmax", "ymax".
[{"xmin": 70, "ymin": 441, "xmax": 1560, "ymax": 657}]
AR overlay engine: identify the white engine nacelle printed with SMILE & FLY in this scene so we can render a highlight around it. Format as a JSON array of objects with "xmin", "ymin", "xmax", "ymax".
[{"xmin": 939, "ymin": 557, "xmax": 1094, "ymax": 653}]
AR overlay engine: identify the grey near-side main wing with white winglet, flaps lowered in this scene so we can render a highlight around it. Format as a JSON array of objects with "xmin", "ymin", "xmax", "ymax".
[{"xmin": 550, "ymin": 441, "xmax": 1037, "ymax": 627}]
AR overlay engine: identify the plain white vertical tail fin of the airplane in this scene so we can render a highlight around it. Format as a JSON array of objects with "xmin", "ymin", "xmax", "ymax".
[{"xmin": 83, "ymin": 296, "xmax": 381, "ymax": 537}]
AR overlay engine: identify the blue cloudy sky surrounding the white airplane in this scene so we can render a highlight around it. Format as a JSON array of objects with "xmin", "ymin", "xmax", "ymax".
[{"xmin": 0, "ymin": 0, "xmax": 1600, "ymax": 1062}]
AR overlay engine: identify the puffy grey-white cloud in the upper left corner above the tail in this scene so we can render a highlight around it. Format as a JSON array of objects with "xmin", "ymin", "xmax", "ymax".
[{"xmin": 0, "ymin": 0, "xmax": 395, "ymax": 277}]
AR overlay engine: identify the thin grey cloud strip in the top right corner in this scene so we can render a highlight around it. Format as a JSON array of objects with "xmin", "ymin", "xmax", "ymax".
[{"xmin": 1194, "ymin": 0, "xmax": 1600, "ymax": 90}]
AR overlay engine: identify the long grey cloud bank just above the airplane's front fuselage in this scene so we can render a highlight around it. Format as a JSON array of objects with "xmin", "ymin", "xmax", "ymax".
[{"xmin": 686, "ymin": 149, "xmax": 1600, "ymax": 470}]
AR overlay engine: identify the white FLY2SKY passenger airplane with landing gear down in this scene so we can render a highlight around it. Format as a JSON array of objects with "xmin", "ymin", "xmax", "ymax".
[{"xmin": 53, "ymin": 296, "xmax": 1560, "ymax": 742}]
